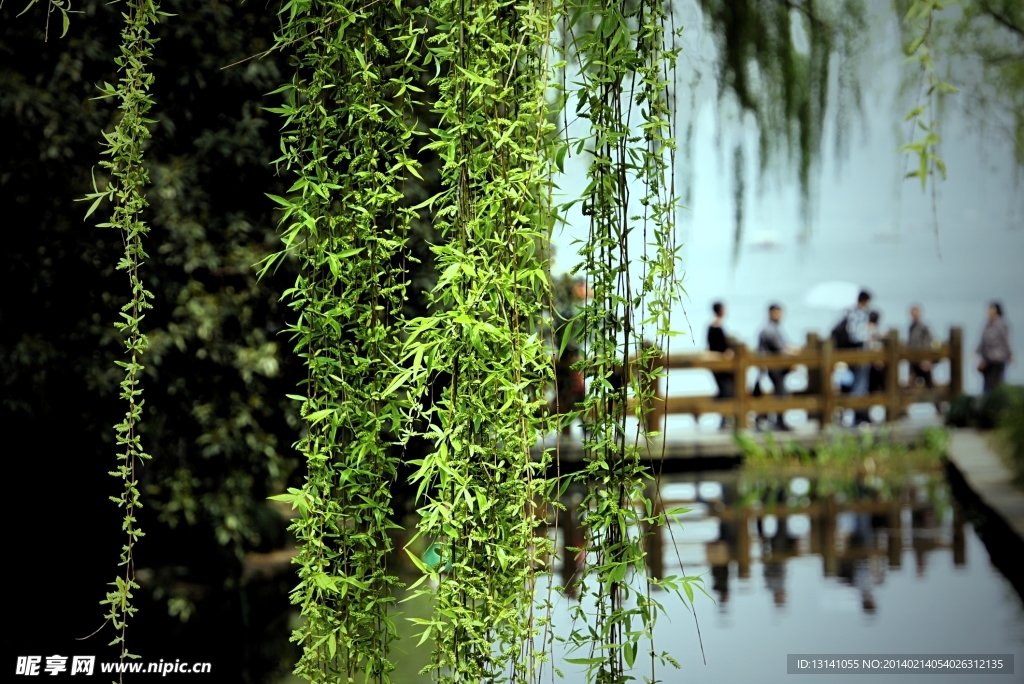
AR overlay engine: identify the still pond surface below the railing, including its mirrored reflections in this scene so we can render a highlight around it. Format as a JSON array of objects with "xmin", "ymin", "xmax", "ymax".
[{"xmin": 385, "ymin": 470, "xmax": 1024, "ymax": 684}]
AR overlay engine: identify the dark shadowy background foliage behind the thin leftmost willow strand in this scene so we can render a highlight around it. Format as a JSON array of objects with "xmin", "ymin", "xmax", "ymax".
[{"xmin": 0, "ymin": 0, "xmax": 302, "ymax": 681}]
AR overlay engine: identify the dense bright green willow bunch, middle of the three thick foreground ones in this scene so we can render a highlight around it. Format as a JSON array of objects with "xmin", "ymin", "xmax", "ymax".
[{"xmin": 404, "ymin": 0, "xmax": 555, "ymax": 683}]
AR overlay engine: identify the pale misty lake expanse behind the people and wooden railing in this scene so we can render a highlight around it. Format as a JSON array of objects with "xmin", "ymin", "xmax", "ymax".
[{"xmin": 553, "ymin": 0, "xmax": 1024, "ymax": 401}]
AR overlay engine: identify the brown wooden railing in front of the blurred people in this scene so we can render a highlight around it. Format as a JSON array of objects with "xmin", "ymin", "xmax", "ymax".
[{"xmin": 645, "ymin": 328, "xmax": 964, "ymax": 432}]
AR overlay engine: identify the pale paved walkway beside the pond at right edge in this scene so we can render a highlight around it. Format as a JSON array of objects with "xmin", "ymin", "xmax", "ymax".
[{"xmin": 948, "ymin": 430, "xmax": 1024, "ymax": 541}]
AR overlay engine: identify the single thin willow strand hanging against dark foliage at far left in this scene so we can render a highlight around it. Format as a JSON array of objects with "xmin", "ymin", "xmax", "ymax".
[{"xmin": 85, "ymin": 0, "xmax": 167, "ymax": 661}]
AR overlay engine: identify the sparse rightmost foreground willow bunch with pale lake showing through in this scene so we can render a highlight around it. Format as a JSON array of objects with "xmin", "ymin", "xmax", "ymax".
[{"xmin": 563, "ymin": 0, "xmax": 700, "ymax": 684}]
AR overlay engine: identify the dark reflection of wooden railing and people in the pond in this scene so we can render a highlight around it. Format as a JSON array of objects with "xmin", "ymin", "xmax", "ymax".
[{"xmin": 649, "ymin": 471, "xmax": 966, "ymax": 613}]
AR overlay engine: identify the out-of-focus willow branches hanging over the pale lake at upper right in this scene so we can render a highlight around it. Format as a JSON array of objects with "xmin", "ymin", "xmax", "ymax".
[{"xmin": 687, "ymin": 0, "xmax": 1024, "ymax": 250}]
